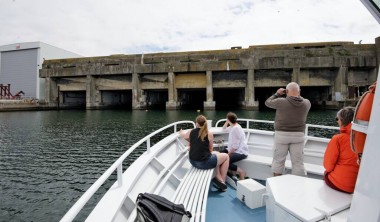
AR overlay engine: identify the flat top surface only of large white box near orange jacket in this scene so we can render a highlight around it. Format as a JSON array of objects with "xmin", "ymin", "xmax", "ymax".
[{"xmin": 267, "ymin": 175, "xmax": 352, "ymax": 221}]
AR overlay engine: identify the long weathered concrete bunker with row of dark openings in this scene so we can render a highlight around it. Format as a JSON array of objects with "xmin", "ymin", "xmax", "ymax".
[{"xmin": 40, "ymin": 38, "xmax": 380, "ymax": 110}]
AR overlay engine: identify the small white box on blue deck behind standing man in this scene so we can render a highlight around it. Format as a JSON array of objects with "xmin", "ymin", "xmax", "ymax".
[{"xmin": 236, "ymin": 179, "xmax": 266, "ymax": 209}]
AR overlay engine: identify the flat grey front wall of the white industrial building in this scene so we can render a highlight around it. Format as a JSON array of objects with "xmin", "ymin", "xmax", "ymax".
[{"xmin": 0, "ymin": 49, "xmax": 38, "ymax": 97}]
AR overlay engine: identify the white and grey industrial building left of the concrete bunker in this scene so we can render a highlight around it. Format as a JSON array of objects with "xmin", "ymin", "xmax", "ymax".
[{"xmin": 0, "ymin": 42, "xmax": 82, "ymax": 99}]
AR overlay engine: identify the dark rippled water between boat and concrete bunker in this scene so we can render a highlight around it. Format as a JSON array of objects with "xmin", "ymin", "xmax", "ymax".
[{"xmin": 0, "ymin": 110, "xmax": 336, "ymax": 221}]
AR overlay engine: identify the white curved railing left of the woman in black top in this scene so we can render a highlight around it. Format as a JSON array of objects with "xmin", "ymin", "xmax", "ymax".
[{"xmin": 60, "ymin": 120, "xmax": 196, "ymax": 222}]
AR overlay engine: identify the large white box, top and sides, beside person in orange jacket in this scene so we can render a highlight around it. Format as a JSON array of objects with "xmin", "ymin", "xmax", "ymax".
[{"xmin": 266, "ymin": 175, "xmax": 352, "ymax": 222}]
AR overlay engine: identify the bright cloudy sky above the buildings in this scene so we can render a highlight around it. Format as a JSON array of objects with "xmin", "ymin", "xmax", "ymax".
[{"xmin": 0, "ymin": 0, "xmax": 380, "ymax": 57}]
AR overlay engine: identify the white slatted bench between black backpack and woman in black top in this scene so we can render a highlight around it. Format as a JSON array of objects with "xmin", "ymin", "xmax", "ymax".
[{"xmin": 171, "ymin": 166, "xmax": 214, "ymax": 222}]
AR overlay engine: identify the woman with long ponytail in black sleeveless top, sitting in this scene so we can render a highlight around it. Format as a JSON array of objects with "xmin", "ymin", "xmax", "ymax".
[{"xmin": 179, "ymin": 115, "xmax": 229, "ymax": 191}]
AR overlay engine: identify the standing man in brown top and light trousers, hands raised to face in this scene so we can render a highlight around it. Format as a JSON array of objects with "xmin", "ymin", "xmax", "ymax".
[{"xmin": 265, "ymin": 82, "xmax": 311, "ymax": 176}]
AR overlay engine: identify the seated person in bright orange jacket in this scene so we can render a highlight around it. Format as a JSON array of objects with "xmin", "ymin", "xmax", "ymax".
[{"xmin": 323, "ymin": 107, "xmax": 359, "ymax": 193}]
